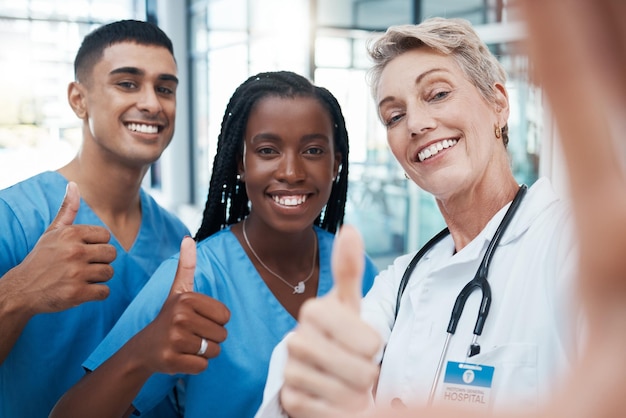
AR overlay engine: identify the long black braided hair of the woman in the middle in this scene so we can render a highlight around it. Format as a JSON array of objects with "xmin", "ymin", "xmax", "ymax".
[{"xmin": 195, "ymin": 71, "xmax": 349, "ymax": 242}]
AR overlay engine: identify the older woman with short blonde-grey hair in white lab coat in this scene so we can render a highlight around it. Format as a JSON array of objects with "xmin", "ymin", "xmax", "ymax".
[{"xmin": 257, "ymin": 18, "xmax": 577, "ymax": 417}]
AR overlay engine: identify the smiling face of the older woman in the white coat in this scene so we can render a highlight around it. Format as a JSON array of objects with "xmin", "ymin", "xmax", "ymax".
[{"xmin": 377, "ymin": 47, "xmax": 508, "ymax": 200}]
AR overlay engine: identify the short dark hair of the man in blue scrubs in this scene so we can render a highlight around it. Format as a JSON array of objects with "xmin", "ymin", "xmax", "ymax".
[{"xmin": 74, "ymin": 19, "xmax": 174, "ymax": 81}]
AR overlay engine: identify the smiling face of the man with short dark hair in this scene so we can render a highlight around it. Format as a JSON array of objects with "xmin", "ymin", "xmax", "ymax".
[{"xmin": 68, "ymin": 42, "xmax": 178, "ymax": 167}]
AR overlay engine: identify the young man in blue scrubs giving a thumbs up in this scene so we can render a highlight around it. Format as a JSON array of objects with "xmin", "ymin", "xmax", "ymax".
[{"xmin": 0, "ymin": 20, "xmax": 189, "ymax": 418}]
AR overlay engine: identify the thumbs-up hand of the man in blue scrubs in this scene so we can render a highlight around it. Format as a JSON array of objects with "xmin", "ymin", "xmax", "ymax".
[{"xmin": 2, "ymin": 182, "xmax": 116, "ymax": 316}]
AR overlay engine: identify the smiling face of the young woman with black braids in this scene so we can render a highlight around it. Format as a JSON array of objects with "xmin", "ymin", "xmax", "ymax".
[{"xmin": 240, "ymin": 96, "xmax": 341, "ymax": 232}]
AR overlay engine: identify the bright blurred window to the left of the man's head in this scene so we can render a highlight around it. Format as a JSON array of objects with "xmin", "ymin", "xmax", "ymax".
[{"xmin": 0, "ymin": 0, "xmax": 143, "ymax": 188}]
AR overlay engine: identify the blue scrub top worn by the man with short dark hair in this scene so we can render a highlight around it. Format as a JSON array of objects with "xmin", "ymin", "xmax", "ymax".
[{"xmin": 0, "ymin": 172, "xmax": 189, "ymax": 418}]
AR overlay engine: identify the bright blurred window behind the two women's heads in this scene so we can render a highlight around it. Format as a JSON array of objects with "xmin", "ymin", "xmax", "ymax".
[{"xmin": 190, "ymin": 0, "xmax": 543, "ymax": 268}]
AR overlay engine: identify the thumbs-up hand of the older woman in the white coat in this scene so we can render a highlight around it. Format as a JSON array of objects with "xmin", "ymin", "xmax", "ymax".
[{"xmin": 280, "ymin": 225, "xmax": 381, "ymax": 418}]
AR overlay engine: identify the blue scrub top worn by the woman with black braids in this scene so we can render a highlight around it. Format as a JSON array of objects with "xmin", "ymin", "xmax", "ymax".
[{"xmin": 85, "ymin": 227, "xmax": 377, "ymax": 418}]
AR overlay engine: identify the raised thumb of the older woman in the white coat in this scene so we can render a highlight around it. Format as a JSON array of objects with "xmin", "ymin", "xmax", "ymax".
[{"xmin": 331, "ymin": 225, "xmax": 365, "ymax": 312}]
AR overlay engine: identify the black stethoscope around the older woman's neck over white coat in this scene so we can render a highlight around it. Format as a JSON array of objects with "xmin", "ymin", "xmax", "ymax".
[{"xmin": 394, "ymin": 184, "xmax": 528, "ymax": 406}]
